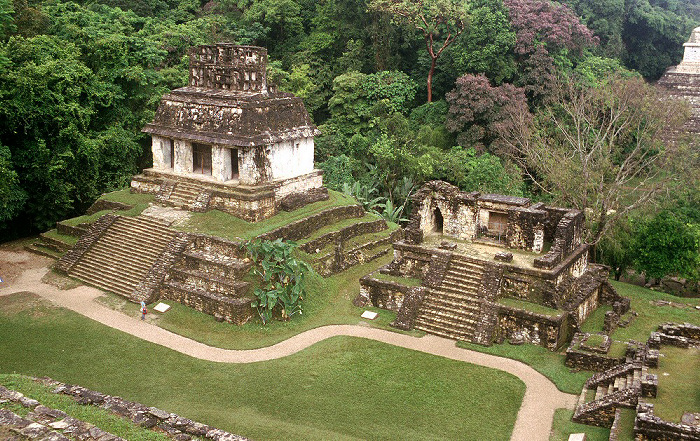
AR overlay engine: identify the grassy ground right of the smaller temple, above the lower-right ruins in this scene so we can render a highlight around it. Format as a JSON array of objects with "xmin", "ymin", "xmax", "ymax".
[{"xmin": 582, "ymin": 281, "xmax": 700, "ymax": 342}]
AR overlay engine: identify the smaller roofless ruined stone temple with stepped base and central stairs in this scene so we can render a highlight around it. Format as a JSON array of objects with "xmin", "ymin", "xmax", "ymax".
[{"xmin": 355, "ymin": 181, "xmax": 629, "ymax": 349}]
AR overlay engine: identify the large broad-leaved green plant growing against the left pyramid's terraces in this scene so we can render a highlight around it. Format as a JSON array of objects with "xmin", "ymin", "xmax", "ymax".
[{"xmin": 245, "ymin": 239, "xmax": 313, "ymax": 324}]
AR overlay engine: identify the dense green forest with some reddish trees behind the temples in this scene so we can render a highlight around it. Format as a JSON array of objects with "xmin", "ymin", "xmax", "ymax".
[{"xmin": 0, "ymin": 0, "xmax": 700, "ymax": 277}]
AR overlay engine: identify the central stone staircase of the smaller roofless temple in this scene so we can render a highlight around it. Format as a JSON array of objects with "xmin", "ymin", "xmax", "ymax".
[{"xmin": 415, "ymin": 255, "xmax": 484, "ymax": 341}]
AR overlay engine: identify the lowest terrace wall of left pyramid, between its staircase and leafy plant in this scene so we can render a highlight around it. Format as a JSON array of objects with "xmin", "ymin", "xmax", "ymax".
[{"xmin": 160, "ymin": 280, "xmax": 254, "ymax": 325}]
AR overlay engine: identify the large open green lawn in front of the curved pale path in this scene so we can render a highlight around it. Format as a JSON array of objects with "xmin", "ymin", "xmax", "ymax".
[{"xmin": 0, "ymin": 294, "xmax": 525, "ymax": 440}]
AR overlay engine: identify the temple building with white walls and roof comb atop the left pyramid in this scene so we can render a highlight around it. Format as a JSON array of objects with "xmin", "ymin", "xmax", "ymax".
[{"xmin": 131, "ymin": 43, "xmax": 323, "ymax": 221}]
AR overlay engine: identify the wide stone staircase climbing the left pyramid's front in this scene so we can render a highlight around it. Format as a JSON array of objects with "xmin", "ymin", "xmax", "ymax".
[{"xmin": 69, "ymin": 216, "xmax": 175, "ymax": 298}]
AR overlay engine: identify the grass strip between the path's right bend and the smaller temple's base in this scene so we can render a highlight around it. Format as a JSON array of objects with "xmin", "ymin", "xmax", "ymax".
[{"xmin": 457, "ymin": 341, "xmax": 593, "ymax": 395}]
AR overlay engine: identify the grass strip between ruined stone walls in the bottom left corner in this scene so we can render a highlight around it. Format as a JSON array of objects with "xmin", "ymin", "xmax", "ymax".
[{"xmin": 0, "ymin": 374, "xmax": 170, "ymax": 441}]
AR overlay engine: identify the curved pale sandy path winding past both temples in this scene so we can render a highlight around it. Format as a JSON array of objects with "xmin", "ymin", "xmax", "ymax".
[{"xmin": 0, "ymin": 258, "xmax": 577, "ymax": 441}]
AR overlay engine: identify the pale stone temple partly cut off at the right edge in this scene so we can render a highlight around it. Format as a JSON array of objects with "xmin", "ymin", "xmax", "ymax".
[{"xmin": 657, "ymin": 27, "xmax": 700, "ymax": 134}]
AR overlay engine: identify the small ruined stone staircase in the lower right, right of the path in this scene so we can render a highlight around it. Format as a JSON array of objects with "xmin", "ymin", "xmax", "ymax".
[{"xmin": 572, "ymin": 362, "xmax": 646, "ymax": 427}]
